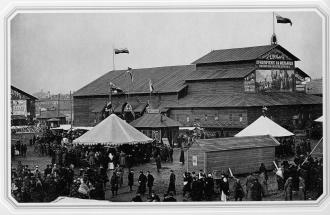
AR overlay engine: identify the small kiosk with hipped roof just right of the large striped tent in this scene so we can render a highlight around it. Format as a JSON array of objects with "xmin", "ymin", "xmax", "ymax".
[{"xmin": 130, "ymin": 113, "xmax": 182, "ymax": 147}]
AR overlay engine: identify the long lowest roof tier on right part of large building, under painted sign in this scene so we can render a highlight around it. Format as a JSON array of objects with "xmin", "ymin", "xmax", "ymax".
[{"xmin": 162, "ymin": 92, "xmax": 322, "ymax": 108}]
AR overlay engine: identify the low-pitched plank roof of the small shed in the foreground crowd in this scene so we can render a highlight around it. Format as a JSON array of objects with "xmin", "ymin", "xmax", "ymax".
[{"xmin": 192, "ymin": 135, "xmax": 280, "ymax": 152}]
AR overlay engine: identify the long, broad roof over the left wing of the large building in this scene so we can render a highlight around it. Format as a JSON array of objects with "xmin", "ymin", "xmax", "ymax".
[{"xmin": 74, "ymin": 65, "xmax": 195, "ymax": 96}]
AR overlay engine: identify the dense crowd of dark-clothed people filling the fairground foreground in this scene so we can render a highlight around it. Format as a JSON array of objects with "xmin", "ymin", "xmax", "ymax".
[{"xmin": 11, "ymin": 127, "xmax": 323, "ymax": 202}]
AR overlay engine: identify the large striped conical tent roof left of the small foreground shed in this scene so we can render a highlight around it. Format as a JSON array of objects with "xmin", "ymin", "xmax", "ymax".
[{"xmin": 73, "ymin": 114, "xmax": 152, "ymax": 145}]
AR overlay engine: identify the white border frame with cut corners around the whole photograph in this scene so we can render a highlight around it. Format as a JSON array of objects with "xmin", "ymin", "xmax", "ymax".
[{"xmin": 0, "ymin": 0, "xmax": 330, "ymax": 214}]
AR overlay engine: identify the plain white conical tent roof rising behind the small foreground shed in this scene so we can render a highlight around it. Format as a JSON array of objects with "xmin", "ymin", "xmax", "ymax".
[{"xmin": 235, "ymin": 116, "xmax": 294, "ymax": 137}]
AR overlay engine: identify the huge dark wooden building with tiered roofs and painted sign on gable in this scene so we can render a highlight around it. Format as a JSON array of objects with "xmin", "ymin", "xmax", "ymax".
[{"xmin": 73, "ymin": 44, "xmax": 322, "ymax": 137}]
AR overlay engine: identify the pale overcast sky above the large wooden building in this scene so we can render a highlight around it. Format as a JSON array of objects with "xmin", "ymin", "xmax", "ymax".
[{"xmin": 11, "ymin": 12, "xmax": 322, "ymax": 93}]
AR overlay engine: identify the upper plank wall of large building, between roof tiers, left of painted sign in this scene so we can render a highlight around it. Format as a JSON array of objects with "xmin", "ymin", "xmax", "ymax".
[{"xmin": 188, "ymin": 79, "xmax": 244, "ymax": 95}]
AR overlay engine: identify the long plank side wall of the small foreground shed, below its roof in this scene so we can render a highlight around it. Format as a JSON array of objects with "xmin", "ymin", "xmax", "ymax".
[{"xmin": 206, "ymin": 147, "xmax": 275, "ymax": 174}]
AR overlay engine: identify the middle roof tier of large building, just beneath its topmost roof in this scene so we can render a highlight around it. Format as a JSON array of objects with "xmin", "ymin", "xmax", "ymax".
[{"xmin": 187, "ymin": 64, "xmax": 255, "ymax": 81}]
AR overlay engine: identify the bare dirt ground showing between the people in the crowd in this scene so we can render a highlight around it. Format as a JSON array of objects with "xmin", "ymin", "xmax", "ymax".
[{"xmin": 12, "ymin": 135, "xmax": 322, "ymax": 202}]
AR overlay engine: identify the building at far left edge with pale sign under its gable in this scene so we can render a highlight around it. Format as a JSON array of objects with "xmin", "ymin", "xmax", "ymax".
[{"xmin": 11, "ymin": 86, "xmax": 38, "ymax": 126}]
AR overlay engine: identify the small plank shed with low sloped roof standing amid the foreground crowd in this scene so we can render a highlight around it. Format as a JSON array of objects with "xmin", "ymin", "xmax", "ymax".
[{"xmin": 187, "ymin": 135, "xmax": 280, "ymax": 174}]
